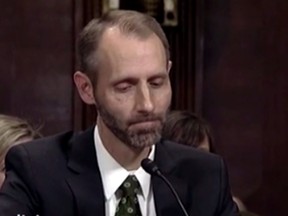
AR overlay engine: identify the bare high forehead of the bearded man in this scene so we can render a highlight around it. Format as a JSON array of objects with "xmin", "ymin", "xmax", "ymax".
[{"xmin": 98, "ymin": 27, "xmax": 167, "ymax": 78}]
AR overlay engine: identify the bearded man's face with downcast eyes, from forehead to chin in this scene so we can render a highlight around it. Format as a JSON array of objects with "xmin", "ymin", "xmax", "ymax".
[{"xmin": 94, "ymin": 28, "xmax": 171, "ymax": 148}]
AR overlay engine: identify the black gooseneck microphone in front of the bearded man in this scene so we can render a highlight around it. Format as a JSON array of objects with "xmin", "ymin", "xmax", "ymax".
[{"xmin": 141, "ymin": 158, "xmax": 189, "ymax": 216}]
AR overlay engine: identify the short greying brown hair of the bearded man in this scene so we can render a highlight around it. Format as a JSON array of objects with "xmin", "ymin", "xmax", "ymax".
[{"xmin": 78, "ymin": 10, "xmax": 170, "ymax": 82}]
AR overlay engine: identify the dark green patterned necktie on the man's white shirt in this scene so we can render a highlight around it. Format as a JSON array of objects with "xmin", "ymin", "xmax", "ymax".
[{"xmin": 115, "ymin": 175, "xmax": 142, "ymax": 216}]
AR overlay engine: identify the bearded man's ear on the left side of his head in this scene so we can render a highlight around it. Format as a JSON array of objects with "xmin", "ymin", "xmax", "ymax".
[{"xmin": 73, "ymin": 71, "xmax": 95, "ymax": 104}]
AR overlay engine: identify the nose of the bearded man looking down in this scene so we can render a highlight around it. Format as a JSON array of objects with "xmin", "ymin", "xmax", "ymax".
[{"xmin": 135, "ymin": 85, "xmax": 154, "ymax": 114}]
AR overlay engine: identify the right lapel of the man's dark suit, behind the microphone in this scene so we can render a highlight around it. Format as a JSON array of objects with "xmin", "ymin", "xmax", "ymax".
[{"xmin": 152, "ymin": 142, "xmax": 188, "ymax": 216}]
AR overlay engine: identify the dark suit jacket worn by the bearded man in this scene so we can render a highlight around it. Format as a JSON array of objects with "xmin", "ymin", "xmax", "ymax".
[{"xmin": 0, "ymin": 128, "xmax": 238, "ymax": 216}]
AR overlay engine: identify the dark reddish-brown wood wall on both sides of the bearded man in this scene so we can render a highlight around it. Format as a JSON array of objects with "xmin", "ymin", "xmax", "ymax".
[{"xmin": 0, "ymin": 0, "xmax": 288, "ymax": 216}]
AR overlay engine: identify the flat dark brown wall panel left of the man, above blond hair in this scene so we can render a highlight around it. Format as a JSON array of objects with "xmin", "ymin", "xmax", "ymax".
[{"xmin": 0, "ymin": 0, "xmax": 74, "ymax": 135}]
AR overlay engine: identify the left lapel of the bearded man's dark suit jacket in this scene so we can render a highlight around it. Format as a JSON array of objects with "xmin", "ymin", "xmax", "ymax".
[{"xmin": 66, "ymin": 127, "xmax": 105, "ymax": 216}]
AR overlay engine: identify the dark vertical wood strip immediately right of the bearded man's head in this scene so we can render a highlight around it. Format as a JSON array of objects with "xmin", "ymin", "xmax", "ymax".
[{"xmin": 164, "ymin": 0, "xmax": 196, "ymax": 111}]
